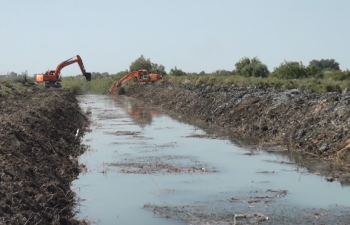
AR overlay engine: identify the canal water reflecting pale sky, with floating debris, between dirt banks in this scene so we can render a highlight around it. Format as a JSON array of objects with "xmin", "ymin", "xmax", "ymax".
[{"xmin": 72, "ymin": 95, "xmax": 350, "ymax": 225}]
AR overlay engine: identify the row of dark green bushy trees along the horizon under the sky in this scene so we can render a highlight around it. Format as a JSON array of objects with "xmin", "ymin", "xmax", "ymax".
[{"xmin": 99, "ymin": 55, "xmax": 350, "ymax": 80}]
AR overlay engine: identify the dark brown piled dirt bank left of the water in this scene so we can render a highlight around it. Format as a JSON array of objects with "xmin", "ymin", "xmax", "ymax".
[{"xmin": 0, "ymin": 82, "xmax": 88, "ymax": 224}]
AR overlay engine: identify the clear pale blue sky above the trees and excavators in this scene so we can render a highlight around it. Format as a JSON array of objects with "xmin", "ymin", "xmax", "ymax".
[{"xmin": 0, "ymin": 0, "xmax": 350, "ymax": 76}]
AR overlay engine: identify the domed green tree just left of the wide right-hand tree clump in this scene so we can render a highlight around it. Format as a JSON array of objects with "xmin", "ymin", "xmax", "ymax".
[{"xmin": 235, "ymin": 57, "xmax": 270, "ymax": 77}]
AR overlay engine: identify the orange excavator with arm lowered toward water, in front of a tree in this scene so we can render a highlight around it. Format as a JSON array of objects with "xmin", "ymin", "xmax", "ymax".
[{"xmin": 107, "ymin": 70, "xmax": 163, "ymax": 94}]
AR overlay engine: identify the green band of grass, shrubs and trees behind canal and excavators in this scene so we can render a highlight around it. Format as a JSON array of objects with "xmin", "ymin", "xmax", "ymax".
[{"xmin": 34, "ymin": 55, "xmax": 350, "ymax": 94}]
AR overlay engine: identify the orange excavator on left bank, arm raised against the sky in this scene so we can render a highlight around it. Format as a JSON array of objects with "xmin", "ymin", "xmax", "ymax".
[{"xmin": 36, "ymin": 55, "xmax": 91, "ymax": 88}]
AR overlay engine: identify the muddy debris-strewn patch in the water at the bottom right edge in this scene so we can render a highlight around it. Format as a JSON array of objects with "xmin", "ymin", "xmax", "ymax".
[{"xmin": 143, "ymin": 193, "xmax": 350, "ymax": 225}]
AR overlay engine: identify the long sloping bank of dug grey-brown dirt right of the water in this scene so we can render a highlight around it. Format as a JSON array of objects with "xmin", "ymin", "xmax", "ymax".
[{"xmin": 127, "ymin": 82, "xmax": 350, "ymax": 162}]
